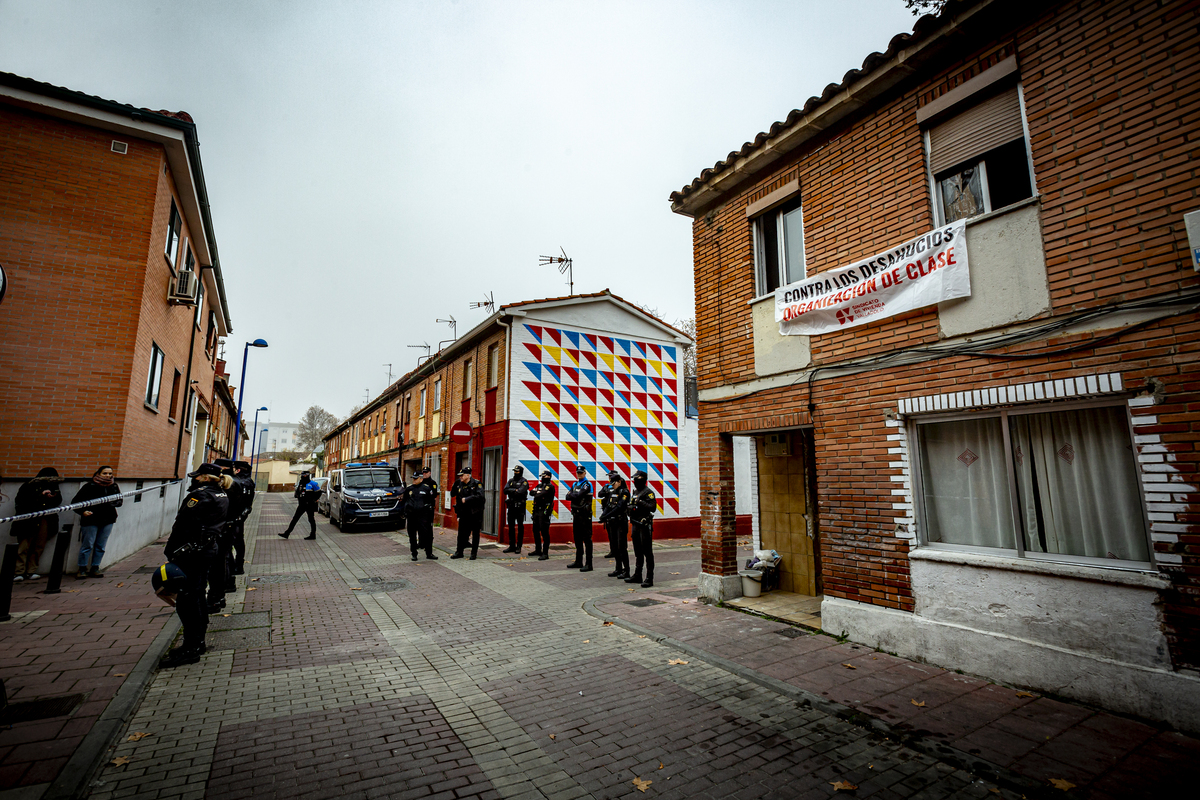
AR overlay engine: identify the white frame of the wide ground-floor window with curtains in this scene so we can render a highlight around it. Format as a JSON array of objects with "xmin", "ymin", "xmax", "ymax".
[{"xmin": 905, "ymin": 397, "xmax": 1157, "ymax": 572}]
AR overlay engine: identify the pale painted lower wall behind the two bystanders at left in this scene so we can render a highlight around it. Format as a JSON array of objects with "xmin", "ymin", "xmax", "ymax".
[{"xmin": 0, "ymin": 479, "xmax": 186, "ymax": 575}]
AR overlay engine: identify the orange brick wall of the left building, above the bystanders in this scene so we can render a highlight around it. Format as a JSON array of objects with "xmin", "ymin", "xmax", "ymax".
[{"xmin": 0, "ymin": 106, "xmax": 220, "ymax": 477}]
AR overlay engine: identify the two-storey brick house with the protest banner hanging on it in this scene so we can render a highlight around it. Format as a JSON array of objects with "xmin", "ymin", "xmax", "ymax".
[{"xmin": 671, "ymin": 0, "xmax": 1200, "ymax": 729}]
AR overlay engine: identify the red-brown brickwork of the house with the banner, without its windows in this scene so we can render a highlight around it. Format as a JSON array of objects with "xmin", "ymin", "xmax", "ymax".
[{"xmin": 694, "ymin": 1, "xmax": 1200, "ymax": 667}]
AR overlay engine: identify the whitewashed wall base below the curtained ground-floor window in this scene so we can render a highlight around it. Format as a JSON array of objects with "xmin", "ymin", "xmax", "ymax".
[{"xmin": 821, "ymin": 556, "xmax": 1200, "ymax": 732}]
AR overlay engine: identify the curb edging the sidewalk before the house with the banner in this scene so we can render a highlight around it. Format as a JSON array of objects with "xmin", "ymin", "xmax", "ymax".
[{"xmin": 583, "ymin": 595, "xmax": 1061, "ymax": 798}]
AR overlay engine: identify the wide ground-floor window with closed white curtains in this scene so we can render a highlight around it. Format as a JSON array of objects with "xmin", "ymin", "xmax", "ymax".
[{"xmin": 913, "ymin": 404, "xmax": 1150, "ymax": 566}]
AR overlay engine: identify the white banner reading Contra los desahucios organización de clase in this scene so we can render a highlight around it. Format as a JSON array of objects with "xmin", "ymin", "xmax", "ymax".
[{"xmin": 775, "ymin": 219, "xmax": 971, "ymax": 336}]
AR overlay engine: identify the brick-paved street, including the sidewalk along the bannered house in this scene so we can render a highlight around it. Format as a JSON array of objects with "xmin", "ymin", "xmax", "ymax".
[{"xmin": 7, "ymin": 495, "xmax": 1200, "ymax": 800}]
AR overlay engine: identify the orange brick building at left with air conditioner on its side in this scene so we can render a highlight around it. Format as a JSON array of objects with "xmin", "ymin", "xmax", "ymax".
[{"xmin": 0, "ymin": 73, "xmax": 230, "ymax": 566}]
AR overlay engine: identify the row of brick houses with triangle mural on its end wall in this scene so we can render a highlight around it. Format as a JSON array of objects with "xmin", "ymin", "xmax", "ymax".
[{"xmin": 325, "ymin": 290, "xmax": 729, "ymax": 541}]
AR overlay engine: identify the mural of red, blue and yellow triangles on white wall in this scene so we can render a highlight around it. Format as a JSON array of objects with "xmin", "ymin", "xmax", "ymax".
[{"xmin": 509, "ymin": 324, "xmax": 683, "ymax": 519}]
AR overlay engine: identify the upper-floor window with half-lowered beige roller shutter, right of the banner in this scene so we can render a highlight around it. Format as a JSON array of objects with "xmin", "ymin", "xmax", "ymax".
[{"xmin": 925, "ymin": 85, "xmax": 1033, "ymax": 224}]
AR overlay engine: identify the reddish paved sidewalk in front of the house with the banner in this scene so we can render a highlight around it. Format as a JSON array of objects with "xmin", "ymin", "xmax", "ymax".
[{"xmin": 587, "ymin": 591, "xmax": 1200, "ymax": 800}]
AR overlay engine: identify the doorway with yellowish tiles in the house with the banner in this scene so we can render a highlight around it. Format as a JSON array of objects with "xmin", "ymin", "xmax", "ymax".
[{"xmin": 755, "ymin": 429, "xmax": 822, "ymax": 596}]
